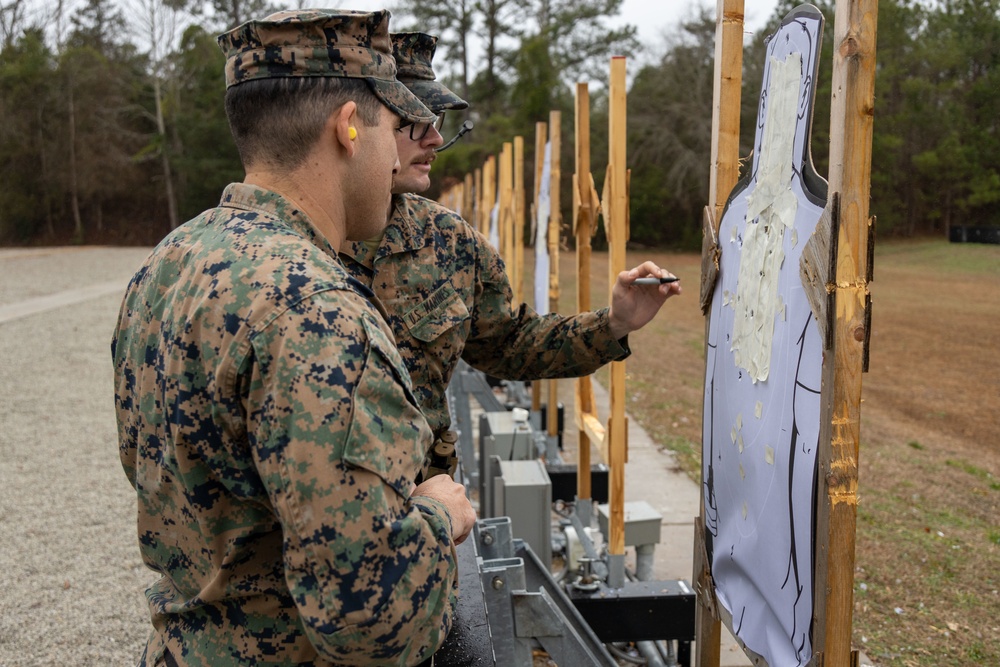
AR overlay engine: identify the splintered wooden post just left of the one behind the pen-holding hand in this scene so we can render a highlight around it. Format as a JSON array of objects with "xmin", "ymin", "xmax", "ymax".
[{"xmin": 573, "ymin": 83, "xmax": 595, "ymax": 500}]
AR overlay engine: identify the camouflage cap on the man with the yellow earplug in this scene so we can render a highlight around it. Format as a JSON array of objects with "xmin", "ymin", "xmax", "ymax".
[{"xmin": 218, "ymin": 9, "xmax": 434, "ymax": 123}]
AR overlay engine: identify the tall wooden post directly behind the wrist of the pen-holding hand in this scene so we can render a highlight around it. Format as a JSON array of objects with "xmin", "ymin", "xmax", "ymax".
[{"xmin": 604, "ymin": 56, "xmax": 628, "ymax": 556}]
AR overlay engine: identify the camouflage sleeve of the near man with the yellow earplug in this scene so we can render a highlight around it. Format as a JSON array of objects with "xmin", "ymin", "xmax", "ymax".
[{"xmin": 248, "ymin": 290, "xmax": 457, "ymax": 665}]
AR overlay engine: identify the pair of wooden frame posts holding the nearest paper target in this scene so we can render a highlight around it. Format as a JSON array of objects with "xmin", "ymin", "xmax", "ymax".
[{"xmin": 693, "ymin": 0, "xmax": 877, "ymax": 667}]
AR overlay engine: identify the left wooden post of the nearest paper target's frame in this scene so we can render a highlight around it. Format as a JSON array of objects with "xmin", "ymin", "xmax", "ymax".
[{"xmin": 692, "ymin": 0, "xmax": 743, "ymax": 667}]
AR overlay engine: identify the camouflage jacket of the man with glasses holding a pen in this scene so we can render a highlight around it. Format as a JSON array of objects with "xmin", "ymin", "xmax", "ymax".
[{"xmin": 341, "ymin": 194, "xmax": 630, "ymax": 434}]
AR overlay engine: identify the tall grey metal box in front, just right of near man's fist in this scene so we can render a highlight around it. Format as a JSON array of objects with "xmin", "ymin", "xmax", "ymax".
[{"xmin": 494, "ymin": 459, "xmax": 552, "ymax": 565}]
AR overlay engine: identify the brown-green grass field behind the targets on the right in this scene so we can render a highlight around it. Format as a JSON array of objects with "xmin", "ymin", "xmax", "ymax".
[{"xmin": 544, "ymin": 241, "xmax": 1000, "ymax": 667}]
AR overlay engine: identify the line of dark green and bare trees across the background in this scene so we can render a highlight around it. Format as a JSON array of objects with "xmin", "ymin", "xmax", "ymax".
[{"xmin": 0, "ymin": 0, "xmax": 1000, "ymax": 249}]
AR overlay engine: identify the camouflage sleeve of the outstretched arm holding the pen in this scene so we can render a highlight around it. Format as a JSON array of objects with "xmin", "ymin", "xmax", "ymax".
[{"xmin": 462, "ymin": 232, "xmax": 631, "ymax": 380}]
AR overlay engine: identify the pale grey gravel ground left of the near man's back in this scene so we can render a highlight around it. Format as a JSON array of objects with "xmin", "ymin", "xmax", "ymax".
[{"xmin": 0, "ymin": 247, "xmax": 155, "ymax": 667}]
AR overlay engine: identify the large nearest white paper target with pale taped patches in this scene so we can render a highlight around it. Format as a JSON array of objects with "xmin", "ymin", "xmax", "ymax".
[{"xmin": 702, "ymin": 6, "xmax": 826, "ymax": 667}]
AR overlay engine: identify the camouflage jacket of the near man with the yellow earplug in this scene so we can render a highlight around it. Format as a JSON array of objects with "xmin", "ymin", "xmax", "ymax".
[{"xmin": 111, "ymin": 184, "xmax": 456, "ymax": 667}]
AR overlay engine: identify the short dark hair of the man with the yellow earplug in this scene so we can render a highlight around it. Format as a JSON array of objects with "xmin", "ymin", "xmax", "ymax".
[{"xmin": 226, "ymin": 76, "xmax": 383, "ymax": 169}]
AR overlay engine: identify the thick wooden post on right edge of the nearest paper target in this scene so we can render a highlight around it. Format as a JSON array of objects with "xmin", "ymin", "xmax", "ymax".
[{"xmin": 813, "ymin": 0, "xmax": 878, "ymax": 667}]
